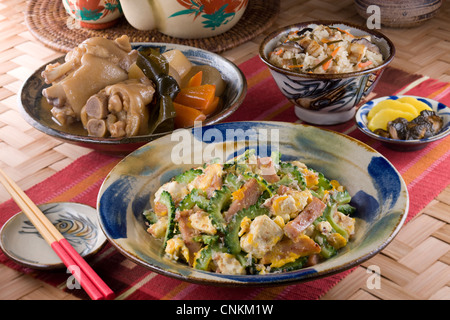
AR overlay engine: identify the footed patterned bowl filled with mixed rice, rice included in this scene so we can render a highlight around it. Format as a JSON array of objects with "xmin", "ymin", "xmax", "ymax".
[{"xmin": 259, "ymin": 20, "xmax": 395, "ymax": 125}]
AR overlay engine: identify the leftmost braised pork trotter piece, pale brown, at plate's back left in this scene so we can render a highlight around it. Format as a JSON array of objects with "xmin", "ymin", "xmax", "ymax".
[{"xmin": 42, "ymin": 35, "xmax": 137, "ymax": 125}]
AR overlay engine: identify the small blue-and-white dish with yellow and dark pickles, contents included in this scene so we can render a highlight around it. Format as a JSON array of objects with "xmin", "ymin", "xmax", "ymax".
[{"xmin": 355, "ymin": 95, "xmax": 450, "ymax": 151}]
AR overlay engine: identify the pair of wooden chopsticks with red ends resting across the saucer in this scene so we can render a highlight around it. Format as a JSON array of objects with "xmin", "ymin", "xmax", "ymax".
[{"xmin": 0, "ymin": 169, "xmax": 114, "ymax": 300}]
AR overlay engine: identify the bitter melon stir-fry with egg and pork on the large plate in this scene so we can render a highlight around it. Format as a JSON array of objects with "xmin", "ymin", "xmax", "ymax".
[{"xmin": 144, "ymin": 150, "xmax": 355, "ymax": 275}]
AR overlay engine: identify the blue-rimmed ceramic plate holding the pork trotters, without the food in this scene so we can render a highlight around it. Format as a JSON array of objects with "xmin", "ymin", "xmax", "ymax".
[{"xmin": 19, "ymin": 42, "xmax": 247, "ymax": 154}]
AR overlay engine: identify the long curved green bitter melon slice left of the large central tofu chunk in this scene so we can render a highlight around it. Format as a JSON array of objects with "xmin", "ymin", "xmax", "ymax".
[{"xmin": 225, "ymin": 192, "xmax": 270, "ymax": 255}]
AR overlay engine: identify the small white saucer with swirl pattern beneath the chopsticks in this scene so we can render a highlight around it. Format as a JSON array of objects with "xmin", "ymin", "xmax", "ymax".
[{"xmin": 0, "ymin": 202, "xmax": 106, "ymax": 269}]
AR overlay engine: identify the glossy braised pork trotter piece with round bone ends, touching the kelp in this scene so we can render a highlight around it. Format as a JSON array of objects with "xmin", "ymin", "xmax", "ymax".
[{"xmin": 81, "ymin": 77, "xmax": 155, "ymax": 138}]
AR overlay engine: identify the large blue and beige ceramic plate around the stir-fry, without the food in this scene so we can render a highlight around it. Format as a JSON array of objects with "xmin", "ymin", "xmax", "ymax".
[{"xmin": 97, "ymin": 122, "xmax": 409, "ymax": 286}]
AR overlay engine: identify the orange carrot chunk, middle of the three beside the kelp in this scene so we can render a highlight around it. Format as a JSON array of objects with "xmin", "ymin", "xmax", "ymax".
[{"xmin": 174, "ymin": 84, "xmax": 216, "ymax": 111}]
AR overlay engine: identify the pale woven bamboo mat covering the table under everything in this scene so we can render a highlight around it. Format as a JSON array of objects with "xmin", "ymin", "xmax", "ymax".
[{"xmin": 0, "ymin": 0, "xmax": 450, "ymax": 300}]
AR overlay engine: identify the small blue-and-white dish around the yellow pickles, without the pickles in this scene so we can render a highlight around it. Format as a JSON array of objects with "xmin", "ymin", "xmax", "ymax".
[{"xmin": 355, "ymin": 95, "xmax": 450, "ymax": 151}]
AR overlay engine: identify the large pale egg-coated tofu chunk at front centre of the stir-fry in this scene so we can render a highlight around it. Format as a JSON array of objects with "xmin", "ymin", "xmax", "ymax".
[{"xmin": 240, "ymin": 215, "xmax": 284, "ymax": 258}]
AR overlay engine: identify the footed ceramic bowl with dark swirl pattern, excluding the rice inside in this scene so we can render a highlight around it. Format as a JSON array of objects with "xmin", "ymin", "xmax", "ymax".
[{"xmin": 259, "ymin": 21, "xmax": 395, "ymax": 125}]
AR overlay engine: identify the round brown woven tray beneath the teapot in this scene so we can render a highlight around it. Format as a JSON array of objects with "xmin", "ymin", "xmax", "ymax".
[{"xmin": 25, "ymin": 0, "xmax": 280, "ymax": 53}]
